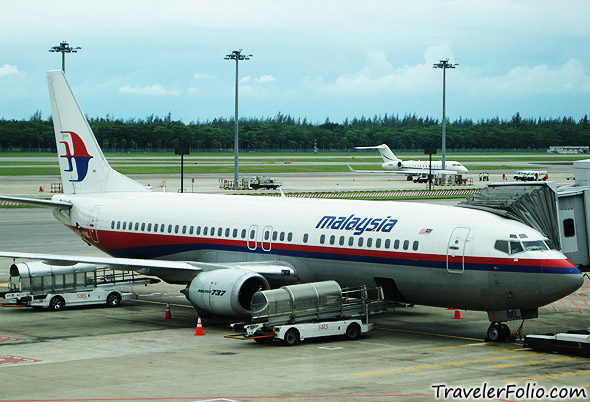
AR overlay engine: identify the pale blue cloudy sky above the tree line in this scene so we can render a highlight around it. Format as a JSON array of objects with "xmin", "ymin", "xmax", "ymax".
[{"xmin": 0, "ymin": 0, "xmax": 590, "ymax": 123}]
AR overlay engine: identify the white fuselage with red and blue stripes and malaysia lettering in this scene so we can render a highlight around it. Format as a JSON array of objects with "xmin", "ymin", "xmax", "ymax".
[{"xmin": 54, "ymin": 193, "xmax": 581, "ymax": 311}]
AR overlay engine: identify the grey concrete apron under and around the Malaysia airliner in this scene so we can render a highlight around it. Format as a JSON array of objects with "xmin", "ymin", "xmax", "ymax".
[{"xmin": 0, "ymin": 204, "xmax": 590, "ymax": 402}]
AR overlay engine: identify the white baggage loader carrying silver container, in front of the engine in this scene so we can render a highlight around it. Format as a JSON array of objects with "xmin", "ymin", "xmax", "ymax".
[{"xmin": 226, "ymin": 281, "xmax": 387, "ymax": 346}]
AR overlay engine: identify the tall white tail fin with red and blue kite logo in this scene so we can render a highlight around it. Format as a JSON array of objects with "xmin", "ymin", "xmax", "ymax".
[{"xmin": 47, "ymin": 70, "xmax": 149, "ymax": 194}]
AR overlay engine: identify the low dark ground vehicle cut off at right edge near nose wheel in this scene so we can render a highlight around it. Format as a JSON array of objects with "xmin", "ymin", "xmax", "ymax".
[{"xmin": 523, "ymin": 329, "xmax": 590, "ymax": 356}]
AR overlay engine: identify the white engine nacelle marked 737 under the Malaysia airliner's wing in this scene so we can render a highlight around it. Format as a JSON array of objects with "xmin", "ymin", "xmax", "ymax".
[{"xmin": 185, "ymin": 268, "xmax": 270, "ymax": 316}]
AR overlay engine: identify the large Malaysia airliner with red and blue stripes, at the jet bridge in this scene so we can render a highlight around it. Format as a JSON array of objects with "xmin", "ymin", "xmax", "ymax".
[{"xmin": 0, "ymin": 71, "xmax": 584, "ymax": 341}]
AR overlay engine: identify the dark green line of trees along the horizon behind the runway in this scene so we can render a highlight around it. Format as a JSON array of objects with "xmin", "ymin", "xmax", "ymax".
[{"xmin": 0, "ymin": 111, "xmax": 590, "ymax": 152}]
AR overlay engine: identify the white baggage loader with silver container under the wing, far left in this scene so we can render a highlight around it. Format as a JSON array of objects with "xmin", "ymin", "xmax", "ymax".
[{"xmin": 0, "ymin": 261, "xmax": 159, "ymax": 311}]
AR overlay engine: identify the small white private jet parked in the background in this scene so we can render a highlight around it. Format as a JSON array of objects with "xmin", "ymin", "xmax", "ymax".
[{"xmin": 348, "ymin": 144, "xmax": 469, "ymax": 181}]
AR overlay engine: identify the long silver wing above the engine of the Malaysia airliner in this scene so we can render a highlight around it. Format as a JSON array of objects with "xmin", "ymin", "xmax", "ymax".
[{"xmin": 0, "ymin": 251, "xmax": 297, "ymax": 283}]
